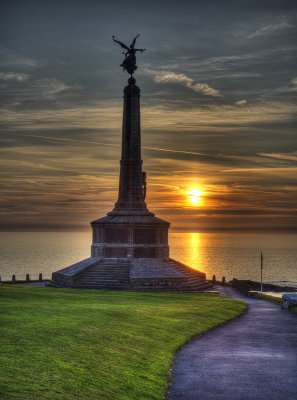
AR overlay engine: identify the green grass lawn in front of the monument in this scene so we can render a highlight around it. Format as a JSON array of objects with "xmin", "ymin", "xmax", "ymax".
[{"xmin": 0, "ymin": 285, "xmax": 246, "ymax": 400}]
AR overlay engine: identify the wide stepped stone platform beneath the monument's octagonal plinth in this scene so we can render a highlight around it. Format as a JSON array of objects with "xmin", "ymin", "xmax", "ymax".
[{"xmin": 48, "ymin": 257, "xmax": 212, "ymax": 292}]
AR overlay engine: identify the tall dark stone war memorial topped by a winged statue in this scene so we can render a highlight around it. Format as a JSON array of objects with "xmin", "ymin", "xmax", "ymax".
[{"xmin": 50, "ymin": 35, "xmax": 210, "ymax": 291}]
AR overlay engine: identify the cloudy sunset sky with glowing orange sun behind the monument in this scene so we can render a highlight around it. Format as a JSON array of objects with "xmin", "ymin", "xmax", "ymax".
[{"xmin": 0, "ymin": 0, "xmax": 297, "ymax": 232}]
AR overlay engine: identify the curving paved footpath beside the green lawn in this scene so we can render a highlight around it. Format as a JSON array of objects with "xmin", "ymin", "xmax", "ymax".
[{"xmin": 167, "ymin": 285, "xmax": 297, "ymax": 400}]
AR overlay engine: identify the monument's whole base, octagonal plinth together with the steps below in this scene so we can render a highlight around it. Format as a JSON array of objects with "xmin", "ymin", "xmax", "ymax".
[{"xmin": 49, "ymin": 210, "xmax": 211, "ymax": 291}]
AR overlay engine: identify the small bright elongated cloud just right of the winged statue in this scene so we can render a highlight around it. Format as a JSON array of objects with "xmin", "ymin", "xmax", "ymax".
[{"xmin": 145, "ymin": 70, "xmax": 222, "ymax": 97}]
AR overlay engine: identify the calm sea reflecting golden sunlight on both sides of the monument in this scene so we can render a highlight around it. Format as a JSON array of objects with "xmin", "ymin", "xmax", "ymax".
[{"xmin": 0, "ymin": 232, "xmax": 297, "ymax": 287}]
